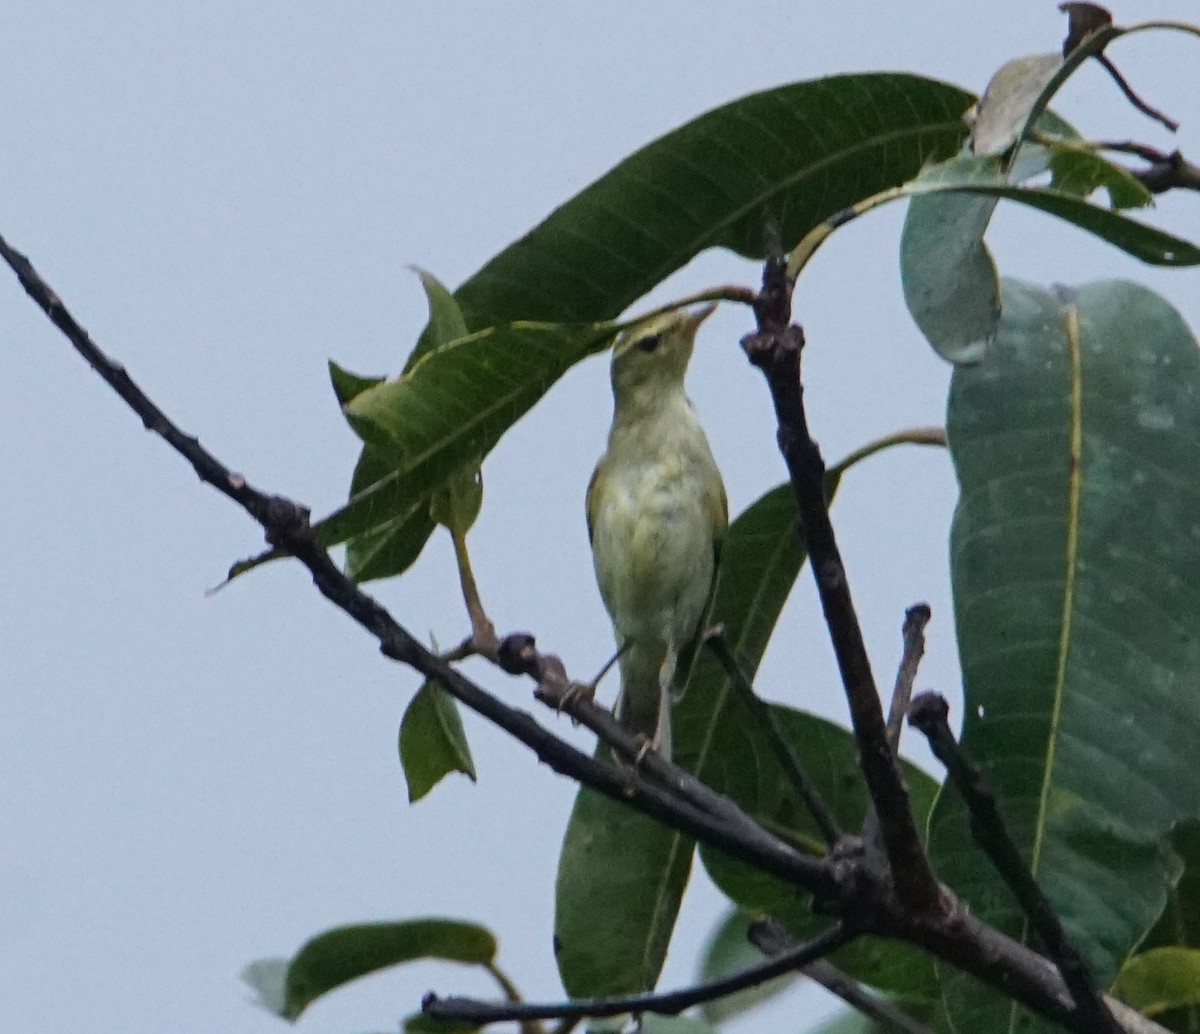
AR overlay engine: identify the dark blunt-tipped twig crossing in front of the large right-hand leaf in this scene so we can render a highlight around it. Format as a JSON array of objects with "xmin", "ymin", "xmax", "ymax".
[{"xmin": 908, "ymin": 693, "xmax": 1122, "ymax": 1034}]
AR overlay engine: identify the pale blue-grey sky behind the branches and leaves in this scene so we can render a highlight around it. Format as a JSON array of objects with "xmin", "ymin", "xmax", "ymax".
[{"xmin": 0, "ymin": 0, "xmax": 1200, "ymax": 1034}]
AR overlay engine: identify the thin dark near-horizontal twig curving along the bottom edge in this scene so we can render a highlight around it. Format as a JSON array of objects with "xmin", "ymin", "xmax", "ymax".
[{"xmin": 421, "ymin": 926, "xmax": 856, "ymax": 1023}]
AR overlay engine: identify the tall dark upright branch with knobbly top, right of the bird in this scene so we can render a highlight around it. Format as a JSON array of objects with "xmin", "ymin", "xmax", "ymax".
[{"xmin": 742, "ymin": 256, "xmax": 942, "ymax": 913}]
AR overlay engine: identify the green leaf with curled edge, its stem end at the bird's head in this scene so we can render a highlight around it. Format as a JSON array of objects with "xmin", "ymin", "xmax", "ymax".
[{"xmin": 317, "ymin": 323, "xmax": 612, "ymax": 570}]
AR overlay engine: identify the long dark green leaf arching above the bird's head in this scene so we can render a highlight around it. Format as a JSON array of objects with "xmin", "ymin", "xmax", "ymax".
[{"xmin": 318, "ymin": 73, "xmax": 973, "ymax": 566}]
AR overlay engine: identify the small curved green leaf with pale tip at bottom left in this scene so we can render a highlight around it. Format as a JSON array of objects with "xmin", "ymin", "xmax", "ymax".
[{"xmin": 242, "ymin": 919, "xmax": 496, "ymax": 1020}]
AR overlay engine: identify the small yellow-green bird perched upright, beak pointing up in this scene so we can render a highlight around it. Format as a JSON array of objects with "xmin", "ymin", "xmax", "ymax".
[{"xmin": 588, "ymin": 305, "xmax": 730, "ymax": 759}]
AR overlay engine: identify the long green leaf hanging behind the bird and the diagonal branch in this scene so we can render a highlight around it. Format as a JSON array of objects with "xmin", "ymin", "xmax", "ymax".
[{"xmin": 554, "ymin": 428, "xmax": 942, "ymax": 998}]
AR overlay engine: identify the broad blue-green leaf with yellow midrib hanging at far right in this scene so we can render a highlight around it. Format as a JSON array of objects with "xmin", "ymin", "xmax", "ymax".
[{"xmin": 930, "ymin": 282, "xmax": 1200, "ymax": 1032}]
